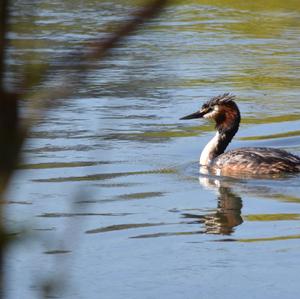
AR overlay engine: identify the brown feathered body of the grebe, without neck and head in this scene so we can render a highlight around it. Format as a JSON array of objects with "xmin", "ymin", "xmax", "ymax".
[{"xmin": 210, "ymin": 147, "xmax": 300, "ymax": 175}]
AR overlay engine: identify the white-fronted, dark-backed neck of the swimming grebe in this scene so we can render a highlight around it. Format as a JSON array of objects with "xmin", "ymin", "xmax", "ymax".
[{"xmin": 199, "ymin": 121, "xmax": 239, "ymax": 166}]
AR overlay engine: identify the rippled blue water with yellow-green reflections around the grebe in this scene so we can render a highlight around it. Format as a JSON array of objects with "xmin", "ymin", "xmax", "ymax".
[{"xmin": 6, "ymin": 0, "xmax": 300, "ymax": 298}]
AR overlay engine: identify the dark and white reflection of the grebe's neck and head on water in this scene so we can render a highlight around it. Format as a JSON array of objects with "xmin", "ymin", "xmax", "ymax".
[{"xmin": 183, "ymin": 174, "xmax": 243, "ymax": 235}]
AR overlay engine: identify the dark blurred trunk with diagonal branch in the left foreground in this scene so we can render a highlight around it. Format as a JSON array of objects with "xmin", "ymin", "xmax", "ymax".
[{"xmin": 0, "ymin": 0, "xmax": 167, "ymax": 299}]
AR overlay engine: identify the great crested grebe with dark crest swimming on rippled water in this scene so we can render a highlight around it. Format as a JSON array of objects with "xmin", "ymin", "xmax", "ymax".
[{"xmin": 181, "ymin": 93, "xmax": 300, "ymax": 175}]
